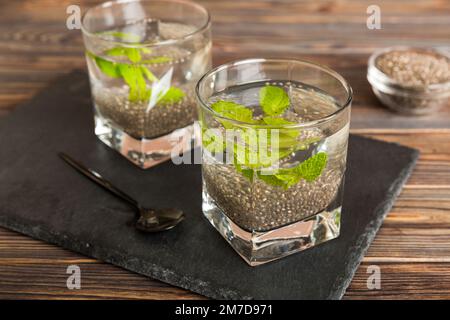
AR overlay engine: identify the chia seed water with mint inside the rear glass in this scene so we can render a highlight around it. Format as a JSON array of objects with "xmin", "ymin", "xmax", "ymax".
[{"xmin": 87, "ymin": 22, "xmax": 210, "ymax": 139}]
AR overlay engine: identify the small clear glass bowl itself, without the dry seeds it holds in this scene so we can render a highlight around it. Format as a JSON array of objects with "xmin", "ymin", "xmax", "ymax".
[{"xmin": 367, "ymin": 46, "xmax": 450, "ymax": 115}]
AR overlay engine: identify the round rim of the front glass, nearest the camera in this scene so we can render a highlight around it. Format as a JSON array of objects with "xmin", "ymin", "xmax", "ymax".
[{"xmin": 195, "ymin": 58, "xmax": 353, "ymax": 129}]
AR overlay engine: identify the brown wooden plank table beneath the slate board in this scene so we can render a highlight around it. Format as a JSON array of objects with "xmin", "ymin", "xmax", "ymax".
[{"xmin": 0, "ymin": 0, "xmax": 450, "ymax": 299}]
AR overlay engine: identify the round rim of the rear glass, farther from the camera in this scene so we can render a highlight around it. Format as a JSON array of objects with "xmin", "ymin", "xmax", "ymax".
[{"xmin": 81, "ymin": 0, "xmax": 211, "ymax": 48}]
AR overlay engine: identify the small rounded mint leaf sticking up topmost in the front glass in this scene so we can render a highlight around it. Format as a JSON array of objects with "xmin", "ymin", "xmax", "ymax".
[{"xmin": 259, "ymin": 86, "xmax": 290, "ymax": 116}]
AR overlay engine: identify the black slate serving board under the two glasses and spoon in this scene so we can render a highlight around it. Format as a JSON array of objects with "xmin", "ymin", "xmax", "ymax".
[{"xmin": 0, "ymin": 71, "xmax": 418, "ymax": 299}]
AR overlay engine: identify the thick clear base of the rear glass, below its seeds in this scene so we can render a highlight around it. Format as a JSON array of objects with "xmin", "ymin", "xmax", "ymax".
[{"xmin": 94, "ymin": 114, "xmax": 196, "ymax": 169}]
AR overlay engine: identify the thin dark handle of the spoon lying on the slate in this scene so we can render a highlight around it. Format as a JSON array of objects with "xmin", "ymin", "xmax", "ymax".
[{"xmin": 58, "ymin": 152, "xmax": 140, "ymax": 210}]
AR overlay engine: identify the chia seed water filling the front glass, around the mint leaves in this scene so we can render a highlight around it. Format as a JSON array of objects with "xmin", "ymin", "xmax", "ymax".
[{"xmin": 202, "ymin": 81, "xmax": 349, "ymax": 231}]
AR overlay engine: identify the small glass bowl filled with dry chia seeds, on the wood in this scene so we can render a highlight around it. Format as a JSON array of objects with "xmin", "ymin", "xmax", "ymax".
[{"xmin": 367, "ymin": 47, "xmax": 450, "ymax": 115}]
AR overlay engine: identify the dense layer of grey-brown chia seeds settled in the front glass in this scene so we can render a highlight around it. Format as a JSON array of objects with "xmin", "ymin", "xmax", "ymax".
[{"xmin": 202, "ymin": 159, "xmax": 342, "ymax": 231}]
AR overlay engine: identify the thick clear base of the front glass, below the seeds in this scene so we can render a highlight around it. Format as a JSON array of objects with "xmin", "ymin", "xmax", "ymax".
[{"xmin": 203, "ymin": 189, "xmax": 341, "ymax": 266}]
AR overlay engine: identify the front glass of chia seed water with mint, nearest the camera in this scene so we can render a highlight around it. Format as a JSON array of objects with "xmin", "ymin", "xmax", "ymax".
[{"xmin": 196, "ymin": 59, "xmax": 352, "ymax": 266}]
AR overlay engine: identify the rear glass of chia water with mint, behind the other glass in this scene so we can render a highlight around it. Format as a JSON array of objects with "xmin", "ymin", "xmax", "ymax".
[{"xmin": 82, "ymin": 0, "xmax": 211, "ymax": 168}]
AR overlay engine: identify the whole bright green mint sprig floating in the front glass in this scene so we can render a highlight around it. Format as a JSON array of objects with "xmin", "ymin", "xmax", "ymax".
[{"xmin": 204, "ymin": 85, "xmax": 328, "ymax": 189}]
